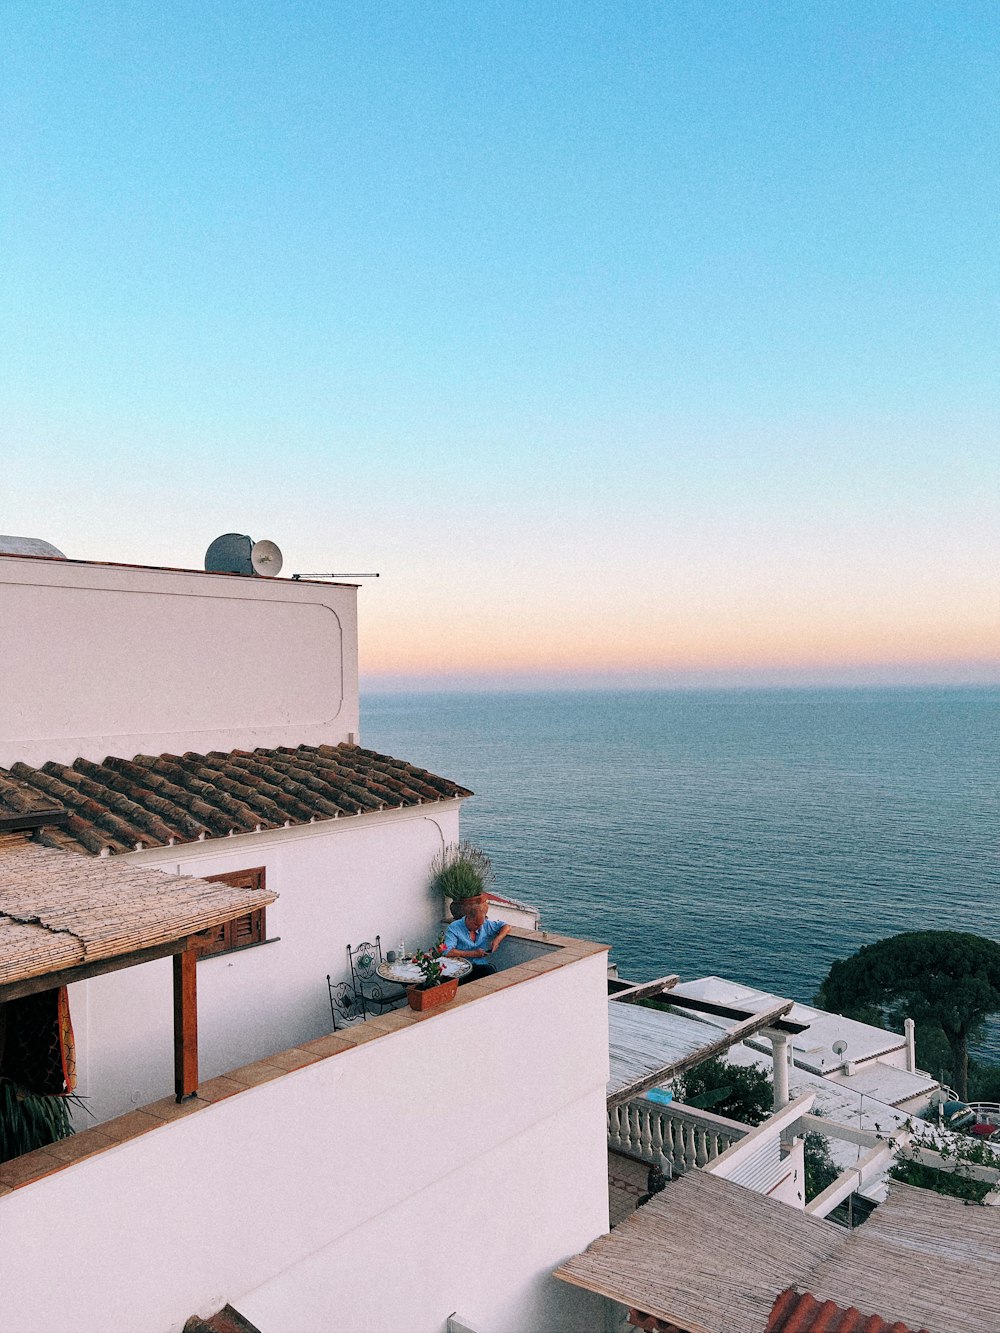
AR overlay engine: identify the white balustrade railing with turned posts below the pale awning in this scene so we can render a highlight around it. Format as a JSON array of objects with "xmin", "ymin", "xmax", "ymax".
[{"xmin": 608, "ymin": 1097, "xmax": 749, "ymax": 1176}]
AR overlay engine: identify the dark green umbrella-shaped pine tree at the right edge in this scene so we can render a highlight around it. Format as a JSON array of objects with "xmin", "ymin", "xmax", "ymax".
[{"xmin": 816, "ymin": 930, "xmax": 1000, "ymax": 1098}]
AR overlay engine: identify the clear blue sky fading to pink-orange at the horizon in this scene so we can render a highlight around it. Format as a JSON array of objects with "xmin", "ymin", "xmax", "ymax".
[{"xmin": 0, "ymin": 0, "xmax": 1000, "ymax": 689}]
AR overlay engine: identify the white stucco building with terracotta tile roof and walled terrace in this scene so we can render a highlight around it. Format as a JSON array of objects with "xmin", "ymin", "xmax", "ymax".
[{"xmin": 0, "ymin": 556, "xmax": 608, "ymax": 1333}]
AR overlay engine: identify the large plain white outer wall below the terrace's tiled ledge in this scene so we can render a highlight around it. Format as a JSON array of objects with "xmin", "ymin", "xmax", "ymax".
[{"xmin": 0, "ymin": 954, "xmax": 608, "ymax": 1333}]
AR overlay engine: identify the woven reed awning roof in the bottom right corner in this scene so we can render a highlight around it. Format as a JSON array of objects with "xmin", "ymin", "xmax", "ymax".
[{"xmin": 555, "ymin": 1170, "xmax": 1000, "ymax": 1333}]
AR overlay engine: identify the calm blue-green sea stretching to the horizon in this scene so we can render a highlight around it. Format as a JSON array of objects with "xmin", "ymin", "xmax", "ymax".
[{"xmin": 361, "ymin": 688, "xmax": 1000, "ymax": 1050}]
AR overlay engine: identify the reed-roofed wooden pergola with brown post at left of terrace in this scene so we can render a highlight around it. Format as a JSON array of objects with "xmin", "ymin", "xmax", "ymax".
[{"xmin": 0, "ymin": 842, "xmax": 277, "ymax": 1101}]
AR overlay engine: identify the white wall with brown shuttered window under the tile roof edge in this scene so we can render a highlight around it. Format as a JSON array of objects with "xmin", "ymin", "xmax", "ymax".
[{"xmin": 69, "ymin": 801, "xmax": 460, "ymax": 1128}]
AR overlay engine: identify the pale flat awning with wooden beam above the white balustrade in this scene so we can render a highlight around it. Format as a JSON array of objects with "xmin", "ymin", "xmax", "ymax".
[{"xmin": 608, "ymin": 1000, "xmax": 792, "ymax": 1106}]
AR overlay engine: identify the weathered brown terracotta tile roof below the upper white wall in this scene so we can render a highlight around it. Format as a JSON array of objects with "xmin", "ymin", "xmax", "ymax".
[{"xmin": 0, "ymin": 745, "xmax": 472, "ymax": 854}]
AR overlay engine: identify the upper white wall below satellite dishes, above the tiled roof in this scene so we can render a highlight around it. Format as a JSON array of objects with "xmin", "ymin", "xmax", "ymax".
[{"xmin": 0, "ymin": 556, "xmax": 359, "ymax": 766}]
